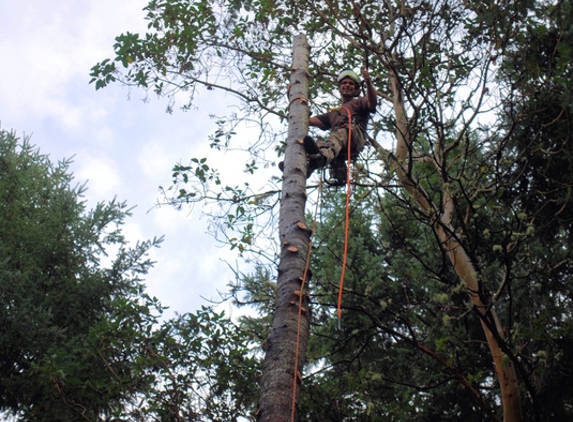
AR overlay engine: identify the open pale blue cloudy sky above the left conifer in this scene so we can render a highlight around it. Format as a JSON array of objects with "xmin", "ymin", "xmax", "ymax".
[{"xmin": 0, "ymin": 0, "xmax": 252, "ymax": 316}]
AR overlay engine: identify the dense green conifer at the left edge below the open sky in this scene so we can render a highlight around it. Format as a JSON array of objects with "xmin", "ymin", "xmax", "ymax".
[{"xmin": 0, "ymin": 131, "xmax": 160, "ymax": 420}]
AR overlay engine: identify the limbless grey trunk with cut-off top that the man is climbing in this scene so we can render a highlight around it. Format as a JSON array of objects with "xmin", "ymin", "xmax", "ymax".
[{"xmin": 257, "ymin": 34, "xmax": 311, "ymax": 422}]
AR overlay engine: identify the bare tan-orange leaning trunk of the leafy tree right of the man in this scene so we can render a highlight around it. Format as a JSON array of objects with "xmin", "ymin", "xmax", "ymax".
[{"xmin": 390, "ymin": 70, "xmax": 523, "ymax": 422}]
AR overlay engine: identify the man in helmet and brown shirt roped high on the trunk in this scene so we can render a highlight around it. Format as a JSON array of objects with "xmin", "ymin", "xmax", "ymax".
[{"xmin": 304, "ymin": 68, "xmax": 378, "ymax": 184}]
